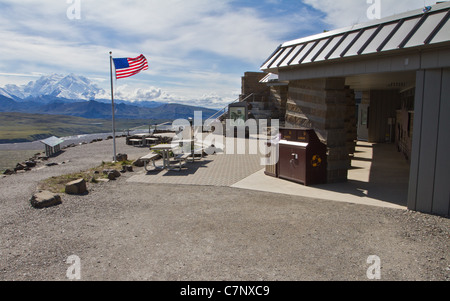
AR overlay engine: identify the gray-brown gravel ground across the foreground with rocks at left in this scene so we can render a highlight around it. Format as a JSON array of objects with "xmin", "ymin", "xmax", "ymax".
[{"xmin": 0, "ymin": 139, "xmax": 450, "ymax": 281}]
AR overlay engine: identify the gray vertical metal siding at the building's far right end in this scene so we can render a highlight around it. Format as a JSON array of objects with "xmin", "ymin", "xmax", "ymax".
[{"xmin": 408, "ymin": 69, "xmax": 450, "ymax": 215}]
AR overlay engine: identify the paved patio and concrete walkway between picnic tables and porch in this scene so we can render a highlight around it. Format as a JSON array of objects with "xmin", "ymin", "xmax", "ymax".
[{"xmin": 128, "ymin": 138, "xmax": 409, "ymax": 209}]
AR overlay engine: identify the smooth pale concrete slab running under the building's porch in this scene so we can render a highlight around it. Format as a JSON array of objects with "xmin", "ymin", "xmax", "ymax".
[{"xmin": 231, "ymin": 142, "xmax": 409, "ymax": 210}]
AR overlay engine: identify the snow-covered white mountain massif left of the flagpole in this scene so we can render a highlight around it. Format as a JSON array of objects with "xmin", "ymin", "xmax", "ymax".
[{"xmin": 0, "ymin": 74, "xmax": 105, "ymax": 100}]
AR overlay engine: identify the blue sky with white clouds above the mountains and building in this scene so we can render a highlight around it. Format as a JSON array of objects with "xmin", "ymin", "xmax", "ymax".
[{"xmin": 0, "ymin": 0, "xmax": 435, "ymax": 107}]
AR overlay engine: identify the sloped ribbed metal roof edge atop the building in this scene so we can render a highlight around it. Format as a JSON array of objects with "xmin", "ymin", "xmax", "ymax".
[{"xmin": 261, "ymin": 2, "xmax": 450, "ymax": 72}]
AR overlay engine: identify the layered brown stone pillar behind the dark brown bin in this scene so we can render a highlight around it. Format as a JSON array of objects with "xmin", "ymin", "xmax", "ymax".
[{"xmin": 286, "ymin": 78, "xmax": 354, "ymax": 183}]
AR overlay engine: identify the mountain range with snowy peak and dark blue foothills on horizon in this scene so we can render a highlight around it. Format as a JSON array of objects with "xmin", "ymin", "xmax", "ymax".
[{"xmin": 0, "ymin": 74, "xmax": 216, "ymax": 120}]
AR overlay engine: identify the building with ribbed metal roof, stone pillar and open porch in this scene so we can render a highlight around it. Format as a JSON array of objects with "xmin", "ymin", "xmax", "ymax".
[{"xmin": 261, "ymin": 1, "xmax": 450, "ymax": 216}]
